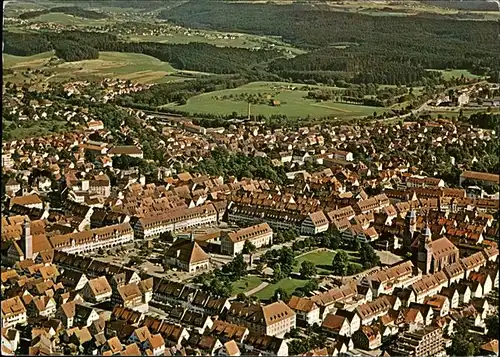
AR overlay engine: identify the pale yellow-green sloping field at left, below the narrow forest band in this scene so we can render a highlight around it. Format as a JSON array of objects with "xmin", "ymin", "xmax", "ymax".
[{"xmin": 3, "ymin": 52, "xmax": 185, "ymax": 83}]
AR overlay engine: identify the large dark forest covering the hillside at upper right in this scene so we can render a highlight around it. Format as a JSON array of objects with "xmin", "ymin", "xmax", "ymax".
[{"xmin": 159, "ymin": 0, "xmax": 500, "ymax": 84}]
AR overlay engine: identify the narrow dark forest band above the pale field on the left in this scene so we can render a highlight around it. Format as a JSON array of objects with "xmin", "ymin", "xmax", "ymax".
[{"xmin": 4, "ymin": 31, "xmax": 280, "ymax": 74}]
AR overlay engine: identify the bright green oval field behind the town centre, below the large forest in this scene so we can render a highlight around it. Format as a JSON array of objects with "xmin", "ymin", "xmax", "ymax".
[{"xmin": 164, "ymin": 82, "xmax": 385, "ymax": 118}]
